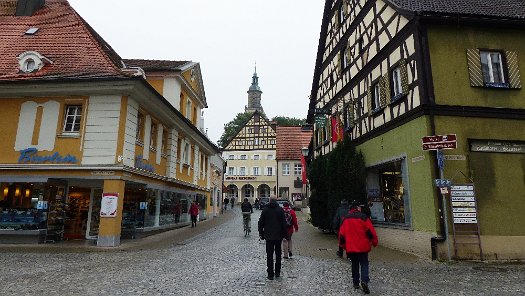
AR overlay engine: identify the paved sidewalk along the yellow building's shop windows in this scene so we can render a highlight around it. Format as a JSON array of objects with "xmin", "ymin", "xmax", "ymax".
[{"xmin": 0, "ymin": 210, "xmax": 235, "ymax": 253}]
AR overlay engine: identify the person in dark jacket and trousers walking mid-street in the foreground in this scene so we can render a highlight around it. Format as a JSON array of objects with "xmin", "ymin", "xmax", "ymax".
[{"xmin": 258, "ymin": 196, "xmax": 287, "ymax": 280}]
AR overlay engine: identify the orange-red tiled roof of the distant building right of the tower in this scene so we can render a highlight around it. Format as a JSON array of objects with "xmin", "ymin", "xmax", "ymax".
[{"xmin": 276, "ymin": 126, "xmax": 313, "ymax": 160}]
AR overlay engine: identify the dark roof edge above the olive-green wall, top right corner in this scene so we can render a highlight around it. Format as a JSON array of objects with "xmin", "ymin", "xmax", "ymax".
[{"xmin": 387, "ymin": 0, "xmax": 525, "ymax": 19}]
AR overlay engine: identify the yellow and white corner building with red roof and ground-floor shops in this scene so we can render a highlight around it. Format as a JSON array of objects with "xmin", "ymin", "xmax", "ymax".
[{"xmin": 0, "ymin": 0, "xmax": 219, "ymax": 246}]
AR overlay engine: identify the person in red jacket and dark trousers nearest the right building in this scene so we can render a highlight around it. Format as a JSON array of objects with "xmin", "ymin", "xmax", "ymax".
[{"xmin": 339, "ymin": 201, "xmax": 378, "ymax": 294}]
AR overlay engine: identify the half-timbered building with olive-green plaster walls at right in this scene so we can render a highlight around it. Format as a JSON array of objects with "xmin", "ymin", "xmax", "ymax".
[{"xmin": 308, "ymin": 0, "xmax": 525, "ymax": 259}]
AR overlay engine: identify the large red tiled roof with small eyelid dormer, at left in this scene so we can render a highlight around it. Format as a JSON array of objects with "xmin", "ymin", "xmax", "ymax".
[{"xmin": 0, "ymin": 0, "xmax": 129, "ymax": 80}]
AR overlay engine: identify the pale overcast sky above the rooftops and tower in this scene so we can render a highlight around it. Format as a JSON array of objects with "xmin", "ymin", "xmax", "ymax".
[{"xmin": 69, "ymin": 0, "xmax": 324, "ymax": 143}]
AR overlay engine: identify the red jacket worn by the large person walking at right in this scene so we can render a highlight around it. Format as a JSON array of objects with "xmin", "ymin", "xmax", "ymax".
[{"xmin": 339, "ymin": 209, "xmax": 378, "ymax": 253}]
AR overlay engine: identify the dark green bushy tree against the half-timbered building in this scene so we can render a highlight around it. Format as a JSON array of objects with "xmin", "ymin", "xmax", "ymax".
[{"xmin": 308, "ymin": 137, "xmax": 366, "ymax": 229}]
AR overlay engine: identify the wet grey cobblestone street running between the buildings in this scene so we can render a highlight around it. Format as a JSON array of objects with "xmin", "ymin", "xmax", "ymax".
[{"xmin": 0, "ymin": 209, "xmax": 525, "ymax": 296}]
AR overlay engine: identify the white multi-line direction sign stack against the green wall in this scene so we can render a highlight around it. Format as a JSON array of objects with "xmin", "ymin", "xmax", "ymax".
[{"xmin": 450, "ymin": 185, "xmax": 478, "ymax": 224}]
